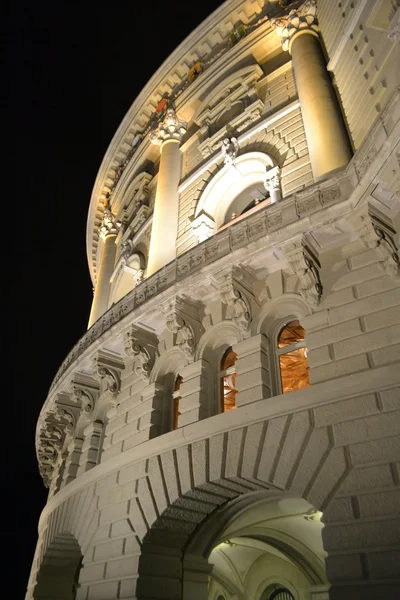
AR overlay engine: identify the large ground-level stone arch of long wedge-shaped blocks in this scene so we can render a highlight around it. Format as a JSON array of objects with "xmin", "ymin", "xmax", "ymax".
[{"xmin": 131, "ymin": 410, "xmax": 349, "ymax": 600}]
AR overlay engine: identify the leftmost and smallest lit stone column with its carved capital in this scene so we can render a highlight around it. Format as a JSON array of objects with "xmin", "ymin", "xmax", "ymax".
[{"xmin": 88, "ymin": 209, "xmax": 120, "ymax": 328}]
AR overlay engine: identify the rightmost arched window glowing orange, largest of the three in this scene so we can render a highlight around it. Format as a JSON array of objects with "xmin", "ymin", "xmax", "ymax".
[{"xmin": 277, "ymin": 321, "xmax": 310, "ymax": 394}]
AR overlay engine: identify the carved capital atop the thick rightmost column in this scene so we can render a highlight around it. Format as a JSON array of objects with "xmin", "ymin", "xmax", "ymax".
[{"xmin": 270, "ymin": 0, "xmax": 319, "ymax": 50}]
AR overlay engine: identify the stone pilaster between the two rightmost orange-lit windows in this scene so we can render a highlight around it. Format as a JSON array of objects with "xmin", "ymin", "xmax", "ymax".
[{"xmin": 233, "ymin": 333, "xmax": 271, "ymax": 407}]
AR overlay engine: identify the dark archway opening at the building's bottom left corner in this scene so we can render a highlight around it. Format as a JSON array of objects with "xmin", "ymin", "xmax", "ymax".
[{"xmin": 33, "ymin": 533, "xmax": 83, "ymax": 600}]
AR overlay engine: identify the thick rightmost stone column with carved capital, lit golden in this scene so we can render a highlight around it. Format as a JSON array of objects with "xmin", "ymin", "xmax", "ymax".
[{"xmin": 271, "ymin": 0, "xmax": 351, "ymax": 181}]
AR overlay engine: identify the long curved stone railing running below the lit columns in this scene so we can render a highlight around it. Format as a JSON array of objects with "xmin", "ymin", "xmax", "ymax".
[{"xmin": 50, "ymin": 169, "xmax": 352, "ymax": 391}]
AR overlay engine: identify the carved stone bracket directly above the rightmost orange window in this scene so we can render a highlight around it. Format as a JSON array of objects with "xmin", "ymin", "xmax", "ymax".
[{"xmin": 282, "ymin": 242, "xmax": 323, "ymax": 306}]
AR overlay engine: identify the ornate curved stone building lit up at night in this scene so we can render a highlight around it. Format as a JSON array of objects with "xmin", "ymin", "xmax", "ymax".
[{"xmin": 26, "ymin": 0, "xmax": 400, "ymax": 600}]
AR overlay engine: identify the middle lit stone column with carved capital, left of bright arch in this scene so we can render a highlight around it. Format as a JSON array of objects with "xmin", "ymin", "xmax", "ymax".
[{"xmin": 147, "ymin": 108, "xmax": 186, "ymax": 276}]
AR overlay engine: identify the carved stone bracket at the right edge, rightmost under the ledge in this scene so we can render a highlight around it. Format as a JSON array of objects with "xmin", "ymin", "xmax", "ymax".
[{"xmin": 358, "ymin": 213, "xmax": 400, "ymax": 278}]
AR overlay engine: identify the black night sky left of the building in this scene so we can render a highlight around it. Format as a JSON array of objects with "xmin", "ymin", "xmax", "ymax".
[{"xmin": 6, "ymin": 0, "xmax": 222, "ymax": 599}]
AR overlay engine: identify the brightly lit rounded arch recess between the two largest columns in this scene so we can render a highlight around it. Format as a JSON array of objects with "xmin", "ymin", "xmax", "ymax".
[{"xmin": 194, "ymin": 152, "xmax": 276, "ymax": 229}]
